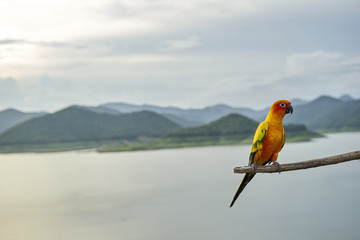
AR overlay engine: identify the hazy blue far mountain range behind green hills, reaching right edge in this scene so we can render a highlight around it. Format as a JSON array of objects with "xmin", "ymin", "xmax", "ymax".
[{"xmin": 99, "ymin": 95, "xmax": 360, "ymax": 131}]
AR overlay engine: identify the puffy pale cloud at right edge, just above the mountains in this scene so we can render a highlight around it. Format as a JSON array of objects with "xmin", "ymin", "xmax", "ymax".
[{"xmin": 277, "ymin": 51, "xmax": 360, "ymax": 97}]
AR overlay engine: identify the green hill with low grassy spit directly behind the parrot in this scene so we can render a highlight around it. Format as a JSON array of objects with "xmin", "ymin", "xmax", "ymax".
[{"xmin": 99, "ymin": 114, "xmax": 322, "ymax": 152}]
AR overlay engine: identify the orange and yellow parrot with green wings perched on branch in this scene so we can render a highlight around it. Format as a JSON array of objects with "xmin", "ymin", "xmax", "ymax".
[{"xmin": 230, "ymin": 100, "xmax": 293, "ymax": 207}]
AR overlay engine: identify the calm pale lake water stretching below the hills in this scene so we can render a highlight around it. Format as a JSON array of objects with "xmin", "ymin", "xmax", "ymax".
[{"xmin": 0, "ymin": 133, "xmax": 360, "ymax": 240}]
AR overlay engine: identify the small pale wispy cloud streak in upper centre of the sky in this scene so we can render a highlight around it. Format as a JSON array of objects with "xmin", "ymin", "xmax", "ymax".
[{"xmin": 158, "ymin": 36, "xmax": 201, "ymax": 51}]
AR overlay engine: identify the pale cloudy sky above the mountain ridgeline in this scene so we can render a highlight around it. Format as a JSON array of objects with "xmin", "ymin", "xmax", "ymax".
[{"xmin": 0, "ymin": 0, "xmax": 360, "ymax": 111}]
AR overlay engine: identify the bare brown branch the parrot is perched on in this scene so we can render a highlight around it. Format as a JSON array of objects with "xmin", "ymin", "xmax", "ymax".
[{"xmin": 234, "ymin": 150, "xmax": 360, "ymax": 173}]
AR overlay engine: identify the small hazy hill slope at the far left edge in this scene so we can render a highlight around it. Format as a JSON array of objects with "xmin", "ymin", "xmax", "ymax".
[{"xmin": 0, "ymin": 109, "xmax": 47, "ymax": 134}]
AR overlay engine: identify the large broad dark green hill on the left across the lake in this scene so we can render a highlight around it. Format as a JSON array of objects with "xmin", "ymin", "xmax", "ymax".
[{"xmin": 0, "ymin": 106, "xmax": 180, "ymax": 145}]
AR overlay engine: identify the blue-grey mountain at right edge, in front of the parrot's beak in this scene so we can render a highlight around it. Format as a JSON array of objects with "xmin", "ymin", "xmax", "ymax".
[{"xmin": 284, "ymin": 96, "xmax": 360, "ymax": 131}]
